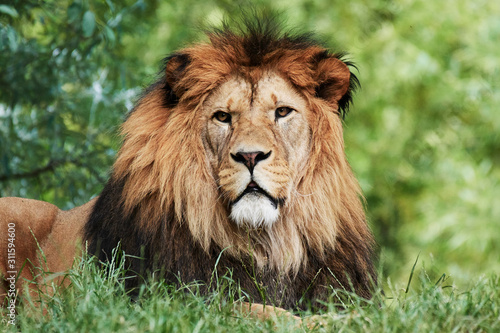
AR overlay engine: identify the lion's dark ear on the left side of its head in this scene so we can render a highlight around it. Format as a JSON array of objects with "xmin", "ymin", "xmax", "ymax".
[{"xmin": 165, "ymin": 53, "xmax": 189, "ymax": 105}]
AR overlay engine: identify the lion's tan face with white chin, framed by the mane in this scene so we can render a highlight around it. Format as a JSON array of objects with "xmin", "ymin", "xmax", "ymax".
[{"xmin": 202, "ymin": 71, "xmax": 311, "ymax": 228}]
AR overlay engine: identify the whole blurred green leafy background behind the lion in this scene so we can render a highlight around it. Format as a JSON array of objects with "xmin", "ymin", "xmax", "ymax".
[{"xmin": 0, "ymin": 0, "xmax": 500, "ymax": 286}]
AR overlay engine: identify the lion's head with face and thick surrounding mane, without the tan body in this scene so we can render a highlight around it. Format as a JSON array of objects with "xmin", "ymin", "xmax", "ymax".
[{"xmin": 86, "ymin": 17, "xmax": 372, "ymax": 304}]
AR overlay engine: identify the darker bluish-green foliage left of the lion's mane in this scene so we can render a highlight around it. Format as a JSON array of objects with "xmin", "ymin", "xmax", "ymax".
[{"xmin": 0, "ymin": 0, "xmax": 158, "ymax": 208}]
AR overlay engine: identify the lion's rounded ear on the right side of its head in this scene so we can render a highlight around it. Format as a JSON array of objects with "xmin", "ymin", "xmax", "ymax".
[{"xmin": 315, "ymin": 56, "xmax": 358, "ymax": 117}]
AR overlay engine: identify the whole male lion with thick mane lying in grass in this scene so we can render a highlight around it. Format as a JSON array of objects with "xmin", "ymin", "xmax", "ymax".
[{"xmin": 0, "ymin": 21, "xmax": 376, "ymax": 309}]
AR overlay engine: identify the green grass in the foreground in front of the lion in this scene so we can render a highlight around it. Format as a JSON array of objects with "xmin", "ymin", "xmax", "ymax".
[{"xmin": 2, "ymin": 253, "xmax": 500, "ymax": 333}]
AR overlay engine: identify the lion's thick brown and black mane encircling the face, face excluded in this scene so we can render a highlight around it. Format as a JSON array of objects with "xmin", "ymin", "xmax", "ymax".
[{"xmin": 85, "ymin": 17, "xmax": 375, "ymax": 308}]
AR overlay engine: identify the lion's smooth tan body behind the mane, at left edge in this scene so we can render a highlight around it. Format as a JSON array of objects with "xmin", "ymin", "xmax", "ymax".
[{"xmin": 0, "ymin": 198, "xmax": 95, "ymax": 304}]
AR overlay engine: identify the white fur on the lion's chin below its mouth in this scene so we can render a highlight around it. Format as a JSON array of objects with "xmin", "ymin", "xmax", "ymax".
[{"xmin": 230, "ymin": 193, "xmax": 279, "ymax": 228}]
